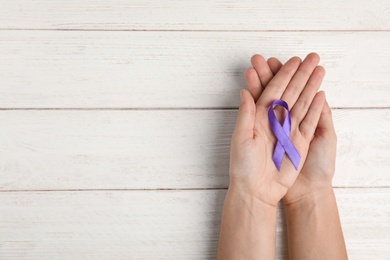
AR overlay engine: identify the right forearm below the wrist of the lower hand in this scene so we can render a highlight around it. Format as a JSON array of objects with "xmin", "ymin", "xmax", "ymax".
[{"xmin": 285, "ymin": 187, "xmax": 348, "ymax": 259}]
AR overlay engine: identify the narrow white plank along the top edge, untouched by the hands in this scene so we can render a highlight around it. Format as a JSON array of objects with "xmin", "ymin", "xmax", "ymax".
[{"xmin": 0, "ymin": 0, "xmax": 390, "ymax": 31}]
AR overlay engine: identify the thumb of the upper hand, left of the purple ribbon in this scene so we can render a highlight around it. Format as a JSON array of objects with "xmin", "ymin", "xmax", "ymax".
[{"xmin": 234, "ymin": 89, "xmax": 256, "ymax": 137}]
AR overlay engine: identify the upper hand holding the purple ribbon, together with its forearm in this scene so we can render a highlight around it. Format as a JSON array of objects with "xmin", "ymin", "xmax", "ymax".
[{"xmin": 218, "ymin": 53, "xmax": 325, "ymax": 259}]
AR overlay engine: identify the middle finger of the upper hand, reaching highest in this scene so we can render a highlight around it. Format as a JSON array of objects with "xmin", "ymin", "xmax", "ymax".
[{"xmin": 282, "ymin": 53, "xmax": 320, "ymax": 108}]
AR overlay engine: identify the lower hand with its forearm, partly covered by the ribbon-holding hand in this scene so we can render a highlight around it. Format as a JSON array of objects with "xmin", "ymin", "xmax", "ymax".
[{"xmin": 253, "ymin": 53, "xmax": 348, "ymax": 259}]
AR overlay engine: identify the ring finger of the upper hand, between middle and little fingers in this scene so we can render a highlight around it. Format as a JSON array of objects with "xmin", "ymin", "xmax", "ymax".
[{"xmin": 291, "ymin": 66, "xmax": 325, "ymax": 125}]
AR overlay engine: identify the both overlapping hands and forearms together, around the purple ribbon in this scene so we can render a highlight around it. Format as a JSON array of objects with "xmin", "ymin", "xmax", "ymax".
[{"xmin": 217, "ymin": 53, "xmax": 347, "ymax": 259}]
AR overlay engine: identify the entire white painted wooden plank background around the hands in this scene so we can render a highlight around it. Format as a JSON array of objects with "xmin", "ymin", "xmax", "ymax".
[{"xmin": 0, "ymin": 0, "xmax": 390, "ymax": 259}]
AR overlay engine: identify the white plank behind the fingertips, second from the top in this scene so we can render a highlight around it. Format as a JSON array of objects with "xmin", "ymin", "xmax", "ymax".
[{"xmin": 0, "ymin": 31, "xmax": 390, "ymax": 108}]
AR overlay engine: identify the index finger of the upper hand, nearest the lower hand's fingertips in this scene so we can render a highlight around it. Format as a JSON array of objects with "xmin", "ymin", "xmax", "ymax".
[{"xmin": 257, "ymin": 57, "xmax": 301, "ymax": 107}]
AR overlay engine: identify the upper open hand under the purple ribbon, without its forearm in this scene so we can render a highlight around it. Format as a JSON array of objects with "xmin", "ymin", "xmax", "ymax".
[{"xmin": 229, "ymin": 54, "xmax": 325, "ymax": 207}]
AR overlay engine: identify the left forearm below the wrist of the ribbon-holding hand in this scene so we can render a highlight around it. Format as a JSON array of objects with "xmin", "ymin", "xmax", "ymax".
[{"xmin": 217, "ymin": 185, "xmax": 276, "ymax": 260}]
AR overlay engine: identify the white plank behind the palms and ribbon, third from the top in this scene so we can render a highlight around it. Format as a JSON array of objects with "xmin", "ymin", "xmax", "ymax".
[{"xmin": 0, "ymin": 109, "xmax": 390, "ymax": 190}]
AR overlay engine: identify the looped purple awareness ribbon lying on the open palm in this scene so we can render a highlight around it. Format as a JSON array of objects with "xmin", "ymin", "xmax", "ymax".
[{"xmin": 268, "ymin": 99, "xmax": 301, "ymax": 171}]
